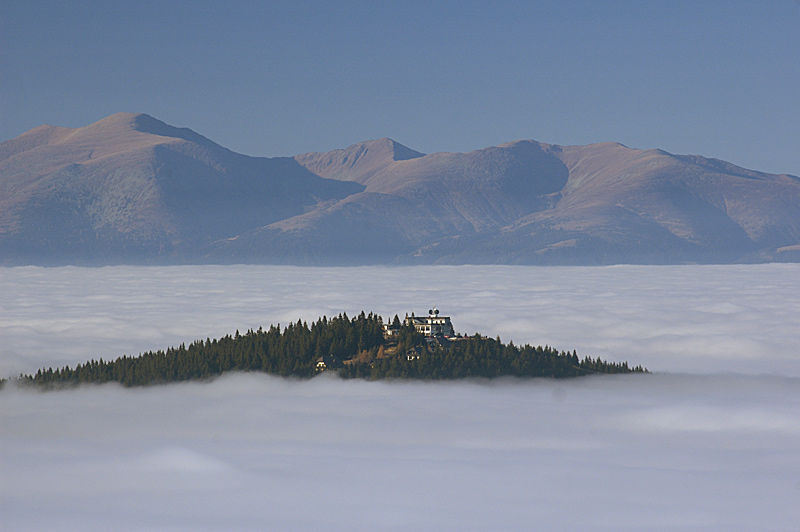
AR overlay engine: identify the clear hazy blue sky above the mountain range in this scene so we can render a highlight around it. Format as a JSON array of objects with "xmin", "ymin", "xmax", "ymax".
[{"xmin": 0, "ymin": 0, "xmax": 800, "ymax": 175}]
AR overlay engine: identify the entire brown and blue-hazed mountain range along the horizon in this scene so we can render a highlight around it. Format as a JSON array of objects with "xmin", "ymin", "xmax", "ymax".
[{"xmin": 0, "ymin": 114, "xmax": 800, "ymax": 264}]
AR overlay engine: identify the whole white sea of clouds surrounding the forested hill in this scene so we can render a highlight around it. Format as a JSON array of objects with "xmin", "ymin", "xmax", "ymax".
[{"xmin": 0, "ymin": 264, "xmax": 800, "ymax": 531}]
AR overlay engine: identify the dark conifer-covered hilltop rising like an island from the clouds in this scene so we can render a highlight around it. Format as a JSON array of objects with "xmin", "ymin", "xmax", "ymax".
[{"xmin": 20, "ymin": 312, "xmax": 647, "ymax": 387}]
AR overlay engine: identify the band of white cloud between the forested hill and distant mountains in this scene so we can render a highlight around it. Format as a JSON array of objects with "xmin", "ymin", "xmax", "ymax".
[{"xmin": 0, "ymin": 264, "xmax": 800, "ymax": 377}]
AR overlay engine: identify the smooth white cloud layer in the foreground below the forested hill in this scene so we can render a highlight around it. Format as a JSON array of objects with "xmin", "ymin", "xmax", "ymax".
[{"xmin": 0, "ymin": 374, "xmax": 800, "ymax": 532}]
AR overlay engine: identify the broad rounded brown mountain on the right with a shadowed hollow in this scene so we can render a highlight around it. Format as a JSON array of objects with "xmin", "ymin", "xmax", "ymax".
[{"xmin": 214, "ymin": 141, "xmax": 800, "ymax": 264}]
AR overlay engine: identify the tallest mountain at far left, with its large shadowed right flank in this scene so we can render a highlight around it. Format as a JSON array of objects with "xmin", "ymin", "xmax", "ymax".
[{"xmin": 0, "ymin": 113, "xmax": 363, "ymax": 264}]
